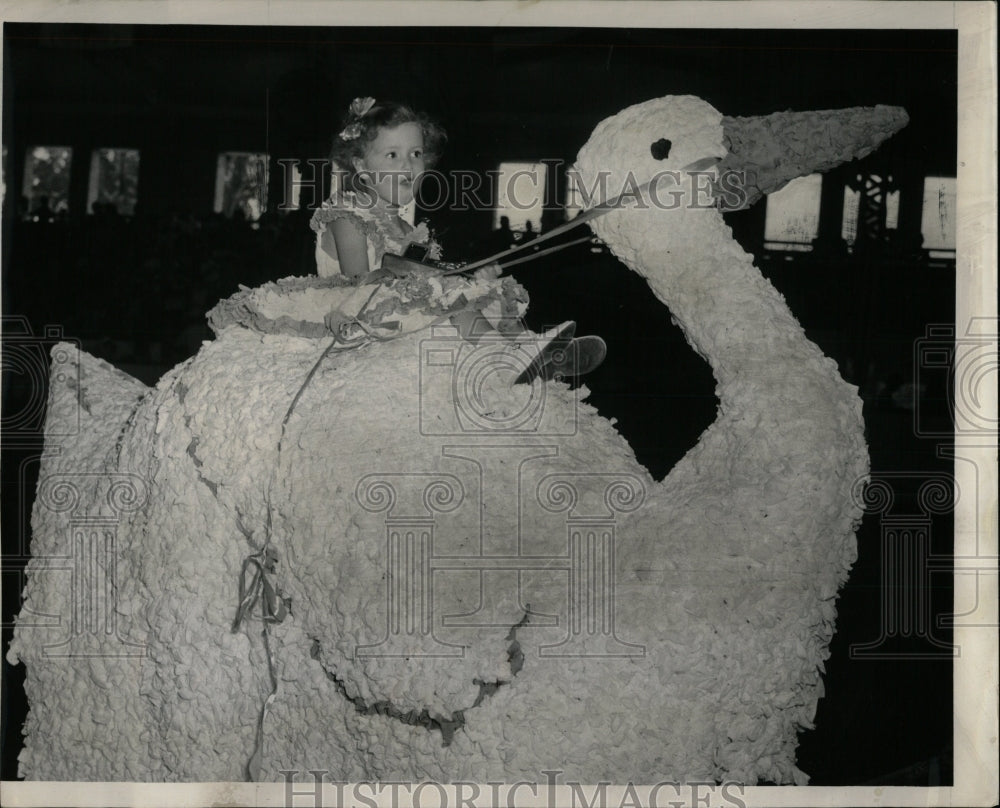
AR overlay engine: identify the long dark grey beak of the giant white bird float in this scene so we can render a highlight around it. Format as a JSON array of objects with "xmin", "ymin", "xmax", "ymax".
[{"xmin": 718, "ymin": 105, "xmax": 910, "ymax": 210}]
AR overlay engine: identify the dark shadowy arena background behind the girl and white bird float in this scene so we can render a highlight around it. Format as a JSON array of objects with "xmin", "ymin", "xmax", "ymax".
[{"xmin": 0, "ymin": 23, "xmax": 957, "ymax": 785}]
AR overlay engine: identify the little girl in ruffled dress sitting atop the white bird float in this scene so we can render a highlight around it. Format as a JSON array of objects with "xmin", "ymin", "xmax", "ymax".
[{"xmin": 310, "ymin": 97, "xmax": 606, "ymax": 382}]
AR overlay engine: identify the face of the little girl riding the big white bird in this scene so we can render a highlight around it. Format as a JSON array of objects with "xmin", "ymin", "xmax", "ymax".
[{"xmin": 354, "ymin": 123, "xmax": 424, "ymax": 206}]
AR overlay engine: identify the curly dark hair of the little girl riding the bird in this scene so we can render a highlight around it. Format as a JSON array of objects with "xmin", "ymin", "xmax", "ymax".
[{"xmin": 330, "ymin": 101, "xmax": 448, "ymax": 191}]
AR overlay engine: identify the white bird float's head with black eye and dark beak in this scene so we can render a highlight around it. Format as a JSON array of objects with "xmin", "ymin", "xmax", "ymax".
[{"xmin": 570, "ymin": 95, "xmax": 909, "ymax": 219}]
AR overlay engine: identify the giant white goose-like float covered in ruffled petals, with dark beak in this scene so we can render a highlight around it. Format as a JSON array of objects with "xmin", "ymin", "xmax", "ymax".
[{"xmin": 9, "ymin": 96, "xmax": 907, "ymax": 784}]
